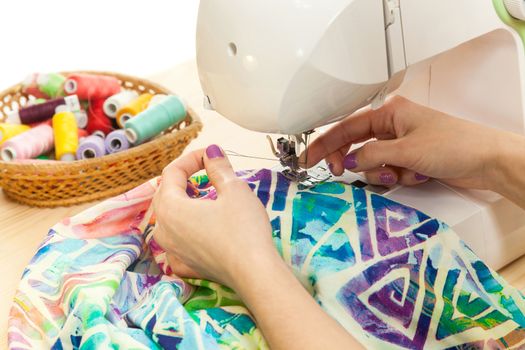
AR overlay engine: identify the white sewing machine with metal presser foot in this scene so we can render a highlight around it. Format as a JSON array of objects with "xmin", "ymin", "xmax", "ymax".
[{"xmin": 197, "ymin": 0, "xmax": 525, "ymax": 268}]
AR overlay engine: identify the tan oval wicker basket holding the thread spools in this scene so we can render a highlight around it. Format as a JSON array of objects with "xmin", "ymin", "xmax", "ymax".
[{"xmin": 0, "ymin": 72, "xmax": 202, "ymax": 207}]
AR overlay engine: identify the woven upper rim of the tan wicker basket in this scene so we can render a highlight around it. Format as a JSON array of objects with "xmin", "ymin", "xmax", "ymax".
[{"xmin": 0, "ymin": 70, "xmax": 202, "ymax": 176}]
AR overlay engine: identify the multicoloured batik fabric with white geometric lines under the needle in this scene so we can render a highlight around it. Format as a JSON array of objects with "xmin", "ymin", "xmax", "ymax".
[{"xmin": 8, "ymin": 170, "xmax": 525, "ymax": 349}]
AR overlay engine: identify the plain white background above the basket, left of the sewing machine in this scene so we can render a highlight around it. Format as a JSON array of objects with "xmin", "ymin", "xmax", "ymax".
[{"xmin": 0, "ymin": 0, "xmax": 198, "ymax": 90}]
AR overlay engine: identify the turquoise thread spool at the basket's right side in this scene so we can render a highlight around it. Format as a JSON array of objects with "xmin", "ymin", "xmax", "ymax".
[{"xmin": 125, "ymin": 96, "xmax": 186, "ymax": 144}]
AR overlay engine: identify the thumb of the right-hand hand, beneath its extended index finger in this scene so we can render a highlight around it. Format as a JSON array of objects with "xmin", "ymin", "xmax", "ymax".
[{"xmin": 343, "ymin": 139, "xmax": 408, "ymax": 173}]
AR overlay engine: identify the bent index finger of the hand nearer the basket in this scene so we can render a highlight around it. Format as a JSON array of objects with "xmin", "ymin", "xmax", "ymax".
[{"xmin": 161, "ymin": 149, "xmax": 204, "ymax": 198}]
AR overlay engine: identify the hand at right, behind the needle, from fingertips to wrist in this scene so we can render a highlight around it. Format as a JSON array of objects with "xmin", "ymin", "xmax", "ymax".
[{"xmin": 302, "ymin": 97, "xmax": 506, "ymax": 189}]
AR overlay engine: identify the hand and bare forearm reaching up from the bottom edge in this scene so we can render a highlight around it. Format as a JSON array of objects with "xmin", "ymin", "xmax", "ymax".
[{"xmin": 154, "ymin": 146, "xmax": 361, "ymax": 350}]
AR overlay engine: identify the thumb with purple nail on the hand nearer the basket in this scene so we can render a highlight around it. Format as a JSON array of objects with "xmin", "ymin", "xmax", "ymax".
[{"xmin": 204, "ymin": 145, "xmax": 238, "ymax": 193}]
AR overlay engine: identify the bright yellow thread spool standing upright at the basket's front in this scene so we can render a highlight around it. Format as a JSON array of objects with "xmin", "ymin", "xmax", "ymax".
[{"xmin": 53, "ymin": 111, "xmax": 78, "ymax": 162}]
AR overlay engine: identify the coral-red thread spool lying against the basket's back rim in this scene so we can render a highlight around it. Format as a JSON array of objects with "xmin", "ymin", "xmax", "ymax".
[{"xmin": 64, "ymin": 74, "xmax": 120, "ymax": 101}]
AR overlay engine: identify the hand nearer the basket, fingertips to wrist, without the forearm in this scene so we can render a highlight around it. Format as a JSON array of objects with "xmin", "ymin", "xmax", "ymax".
[{"xmin": 154, "ymin": 145, "xmax": 280, "ymax": 287}]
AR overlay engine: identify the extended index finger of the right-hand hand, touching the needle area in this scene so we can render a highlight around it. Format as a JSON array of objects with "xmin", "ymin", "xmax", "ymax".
[{"xmin": 301, "ymin": 101, "xmax": 396, "ymax": 168}]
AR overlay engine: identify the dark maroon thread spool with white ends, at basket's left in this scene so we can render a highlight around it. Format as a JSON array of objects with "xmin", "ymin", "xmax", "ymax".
[{"xmin": 7, "ymin": 95, "xmax": 80, "ymax": 124}]
